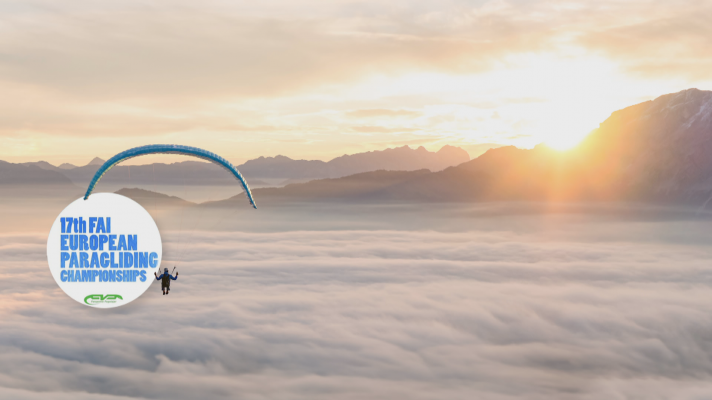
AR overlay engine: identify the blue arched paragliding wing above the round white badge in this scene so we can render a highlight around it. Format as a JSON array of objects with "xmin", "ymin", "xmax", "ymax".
[{"xmin": 84, "ymin": 144, "xmax": 257, "ymax": 208}]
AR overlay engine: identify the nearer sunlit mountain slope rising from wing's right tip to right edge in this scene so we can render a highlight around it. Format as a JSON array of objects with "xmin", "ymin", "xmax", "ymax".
[{"xmin": 232, "ymin": 89, "xmax": 712, "ymax": 205}]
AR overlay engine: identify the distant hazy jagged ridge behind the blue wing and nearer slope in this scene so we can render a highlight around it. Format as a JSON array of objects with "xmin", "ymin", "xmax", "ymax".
[{"xmin": 0, "ymin": 146, "xmax": 470, "ymax": 187}]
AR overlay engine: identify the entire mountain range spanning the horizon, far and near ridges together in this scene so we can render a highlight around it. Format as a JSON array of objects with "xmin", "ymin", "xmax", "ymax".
[{"xmin": 0, "ymin": 89, "xmax": 712, "ymax": 207}]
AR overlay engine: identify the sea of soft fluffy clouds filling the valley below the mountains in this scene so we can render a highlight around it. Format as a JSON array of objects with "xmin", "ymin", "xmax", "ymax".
[{"xmin": 0, "ymin": 205, "xmax": 712, "ymax": 400}]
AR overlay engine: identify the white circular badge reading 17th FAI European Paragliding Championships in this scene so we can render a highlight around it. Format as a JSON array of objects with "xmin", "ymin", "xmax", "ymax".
[{"xmin": 47, "ymin": 193, "xmax": 163, "ymax": 308}]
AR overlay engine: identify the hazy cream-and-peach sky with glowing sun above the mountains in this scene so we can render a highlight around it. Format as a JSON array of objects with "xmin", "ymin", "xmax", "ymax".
[{"xmin": 0, "ymin": 0, "xmax": 712, "ymax": 164}]
